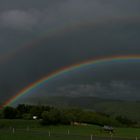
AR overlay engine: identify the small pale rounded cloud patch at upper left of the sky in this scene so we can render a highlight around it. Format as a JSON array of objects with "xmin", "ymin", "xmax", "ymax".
[{"xmin": 0, "ymin": 9, "xmax": 39, "ymax": 29}]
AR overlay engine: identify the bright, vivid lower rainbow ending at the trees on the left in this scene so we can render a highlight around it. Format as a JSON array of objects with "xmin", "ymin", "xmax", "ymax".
[{"xmin": 2, "ymin": 55, "xmax": 140, "ymax": 107}]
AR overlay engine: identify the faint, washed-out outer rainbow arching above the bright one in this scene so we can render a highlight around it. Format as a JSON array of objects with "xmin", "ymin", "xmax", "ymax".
[{"xmin": 0, "ymin": 16, "xmax": 140, "ymax": 63}]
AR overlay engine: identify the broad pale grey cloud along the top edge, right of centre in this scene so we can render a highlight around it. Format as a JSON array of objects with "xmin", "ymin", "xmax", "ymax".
[{"xmin": 43, "ymin": 0, "xmax": 140, "ymax": 26}]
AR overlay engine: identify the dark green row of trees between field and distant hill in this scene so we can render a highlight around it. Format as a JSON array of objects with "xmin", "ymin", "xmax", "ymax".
[{"xmin": 0, "ymin": 104, "xmax": 137, "ymax": 127}]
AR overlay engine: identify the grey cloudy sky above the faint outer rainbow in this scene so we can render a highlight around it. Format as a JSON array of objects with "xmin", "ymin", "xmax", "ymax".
[{"xmin": 0, "ymin": 0, "xmax": 140, "ymax": 54}]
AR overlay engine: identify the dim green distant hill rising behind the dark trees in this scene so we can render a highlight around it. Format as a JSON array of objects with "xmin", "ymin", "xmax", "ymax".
[{"xmin": 23, "ymin": 96, "xmax": 140, "ymax": 121}]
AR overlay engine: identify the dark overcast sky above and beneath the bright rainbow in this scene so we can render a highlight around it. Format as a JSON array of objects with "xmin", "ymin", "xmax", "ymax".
[{"xmin": 0, "ymin": 0, "xmax": 140, "ymax": 104}]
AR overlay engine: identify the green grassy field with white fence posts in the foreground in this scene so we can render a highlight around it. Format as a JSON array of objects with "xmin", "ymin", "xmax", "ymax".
[{"xmin": 0, "ymin": 119, "xmax": 140, "ymax": 140}]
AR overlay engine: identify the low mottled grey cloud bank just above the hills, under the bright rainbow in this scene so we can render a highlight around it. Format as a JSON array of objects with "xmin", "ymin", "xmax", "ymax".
[{"xmin": 50, "ymin": 81, "xmax": 140, "ymax": 100}]
